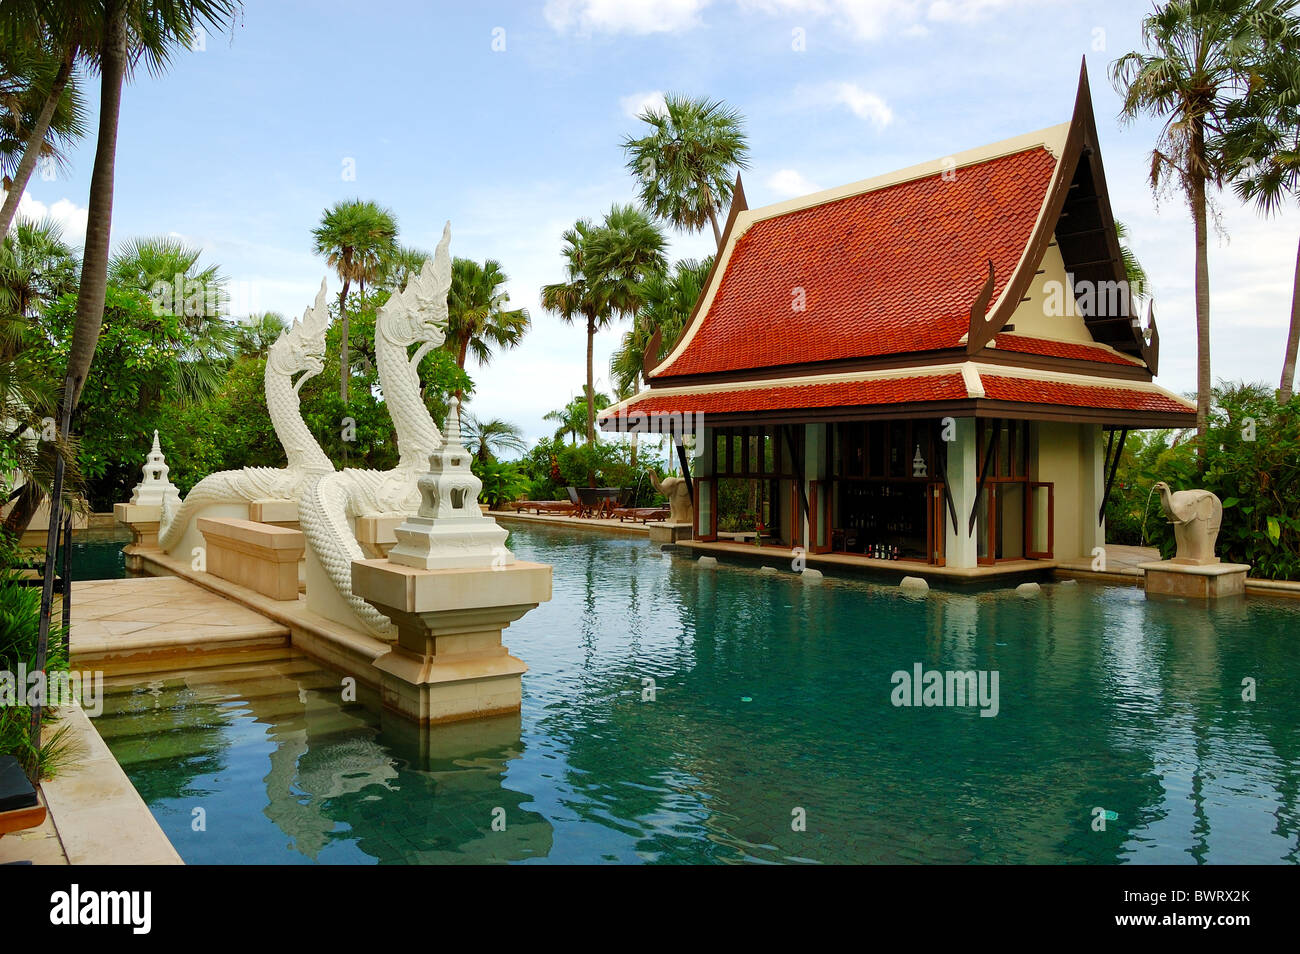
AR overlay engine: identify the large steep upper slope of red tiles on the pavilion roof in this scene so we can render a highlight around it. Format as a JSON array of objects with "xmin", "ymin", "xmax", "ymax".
[{"xmin": 655, "ymin": 147, "xmax": 1057, "ymax": 378}]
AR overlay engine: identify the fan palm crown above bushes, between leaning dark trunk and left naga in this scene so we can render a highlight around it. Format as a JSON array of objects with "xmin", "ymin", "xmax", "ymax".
[{"xmin": 108, "ymin": 235, "xmax": 239, "ymax": 407}]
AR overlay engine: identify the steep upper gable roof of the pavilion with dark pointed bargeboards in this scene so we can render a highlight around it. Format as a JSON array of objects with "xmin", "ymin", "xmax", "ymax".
[{"xmin": 647, "ymin": 58, "xmax": 1158, "ymax": 389}]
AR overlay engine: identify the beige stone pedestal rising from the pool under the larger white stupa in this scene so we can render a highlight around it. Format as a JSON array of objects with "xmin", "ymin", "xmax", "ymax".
[{"xmin": 352, "ymin": 560, "xmax": 551, "ymax": 724}]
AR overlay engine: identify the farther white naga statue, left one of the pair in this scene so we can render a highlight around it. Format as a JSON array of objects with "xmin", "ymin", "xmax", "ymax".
[{"xmin": 159, "ymin": 287, "xmax": 334, "ymax": 558}]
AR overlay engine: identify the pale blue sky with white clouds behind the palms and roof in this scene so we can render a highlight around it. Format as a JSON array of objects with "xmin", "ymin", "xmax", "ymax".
[{"xmin": 23, "ymin": 0, "xmax": 1300, "ymax": 438}]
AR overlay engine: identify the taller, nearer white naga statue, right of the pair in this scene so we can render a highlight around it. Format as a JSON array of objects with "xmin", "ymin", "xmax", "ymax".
[{"xmin": 298, "ymin": 222, "xmax": 451, "ymax": 638}]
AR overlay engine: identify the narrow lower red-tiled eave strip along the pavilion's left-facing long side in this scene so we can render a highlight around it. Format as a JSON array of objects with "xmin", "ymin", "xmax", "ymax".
[{"xmin": 603, "ymin": 372, "xmax": 966, "ymax": 417}]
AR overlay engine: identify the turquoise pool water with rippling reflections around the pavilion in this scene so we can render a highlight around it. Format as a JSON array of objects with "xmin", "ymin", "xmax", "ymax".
[{"xmin": 98, "ymin": 528, "xmax": 1300, "ymax": 863}]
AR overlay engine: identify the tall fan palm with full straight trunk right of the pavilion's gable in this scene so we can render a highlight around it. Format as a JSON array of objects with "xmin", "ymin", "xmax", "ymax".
[{"xmin": 1110, "ymin": 0, "xmax": 1281, "ymax": 461}]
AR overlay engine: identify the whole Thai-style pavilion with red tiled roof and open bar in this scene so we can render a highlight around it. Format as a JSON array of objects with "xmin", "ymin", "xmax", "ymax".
[{"xmin": 602, "ymin": 69, "xmax": 1195, "ymax": 569}]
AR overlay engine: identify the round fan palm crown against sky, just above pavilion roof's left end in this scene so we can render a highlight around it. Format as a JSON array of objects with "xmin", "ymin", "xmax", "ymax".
[{"xmin": 623, "ymin": 94, "xmax": 749, "ymax": 248}]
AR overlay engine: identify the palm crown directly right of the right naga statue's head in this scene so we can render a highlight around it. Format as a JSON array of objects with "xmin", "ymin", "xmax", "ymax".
[{"xmin": 443, "ymin": 259, "xmax": 530, "ymax": 398}]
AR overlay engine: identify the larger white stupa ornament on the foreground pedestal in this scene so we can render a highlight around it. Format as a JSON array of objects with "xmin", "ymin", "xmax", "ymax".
[{"xmin": 389, "ymin": 398, "xmax": 515, "ymax": 569}]
